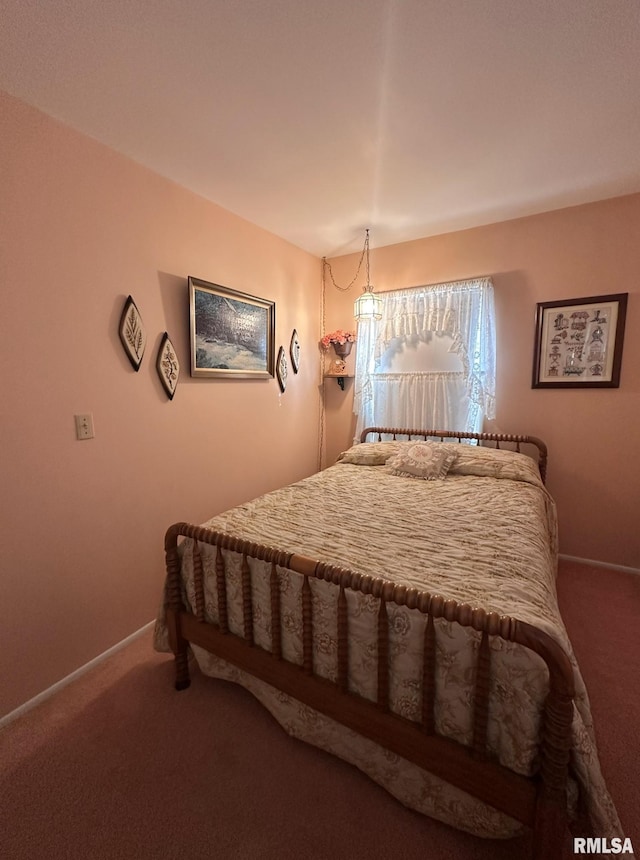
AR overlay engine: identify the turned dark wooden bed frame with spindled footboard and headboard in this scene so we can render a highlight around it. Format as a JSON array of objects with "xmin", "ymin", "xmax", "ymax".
[{"xmin": 165, "ymin": 427, "xmax": 574, "ymax": 860}]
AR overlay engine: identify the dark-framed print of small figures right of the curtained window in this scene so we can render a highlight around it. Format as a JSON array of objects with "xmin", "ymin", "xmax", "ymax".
[{"xmin": 532, "ymin": 293, "xmax": 628, "ymax": 388}]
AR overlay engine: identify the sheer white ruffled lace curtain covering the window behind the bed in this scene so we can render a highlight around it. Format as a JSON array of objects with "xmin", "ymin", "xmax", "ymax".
[{"xmin": 354, "ymin": 278, "xmax": 496, "ymax": 438}]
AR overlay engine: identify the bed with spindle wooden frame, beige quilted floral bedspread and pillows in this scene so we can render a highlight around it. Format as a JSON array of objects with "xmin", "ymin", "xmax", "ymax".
[{"xmin": 155, "ymin": 428, "xmax": 622, "ymax": 860}]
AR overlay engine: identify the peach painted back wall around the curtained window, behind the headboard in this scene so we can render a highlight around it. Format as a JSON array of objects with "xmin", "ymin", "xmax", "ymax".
[{"xmin": 325, "ymin": 194, "xmax": 640, "ymax": 568}]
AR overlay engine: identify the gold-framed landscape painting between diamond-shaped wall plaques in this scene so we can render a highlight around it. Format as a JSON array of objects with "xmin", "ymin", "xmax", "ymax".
[{"xmin": 189, "ymin": 277, "xmax": 276, "ymax": 379}]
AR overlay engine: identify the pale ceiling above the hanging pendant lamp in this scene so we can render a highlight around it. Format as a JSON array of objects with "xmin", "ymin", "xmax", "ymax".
[{"xmin": 0, "ymin": 0, "xmax": 640, "ymax": 256}]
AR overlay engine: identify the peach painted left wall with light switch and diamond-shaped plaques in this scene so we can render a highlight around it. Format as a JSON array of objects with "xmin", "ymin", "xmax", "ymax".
[{"xmin": 0, "ymin": 93, "xmax": 320, "ymax": 715}]
